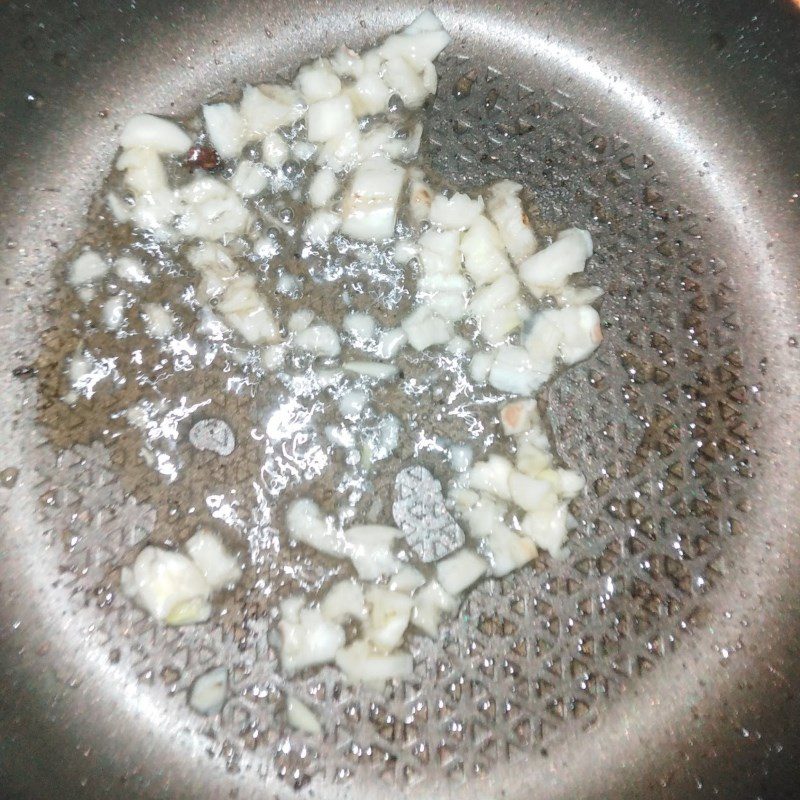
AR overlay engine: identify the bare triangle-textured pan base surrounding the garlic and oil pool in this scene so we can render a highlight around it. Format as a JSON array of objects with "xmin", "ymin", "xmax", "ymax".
[{"xmin": 32, "ymin": 59, "xmax": 750, "ymax": 788}]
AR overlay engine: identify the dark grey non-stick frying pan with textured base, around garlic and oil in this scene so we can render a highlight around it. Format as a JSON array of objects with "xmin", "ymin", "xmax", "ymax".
[{"xmin": 0, "ymin": 0, "xmax": 800, "ymax": 800}]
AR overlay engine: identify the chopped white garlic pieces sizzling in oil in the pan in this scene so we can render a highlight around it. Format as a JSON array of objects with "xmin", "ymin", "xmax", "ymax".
[{"xmin": 70, "ymin": 11, "xmax": 601, "ymax": 712}]
